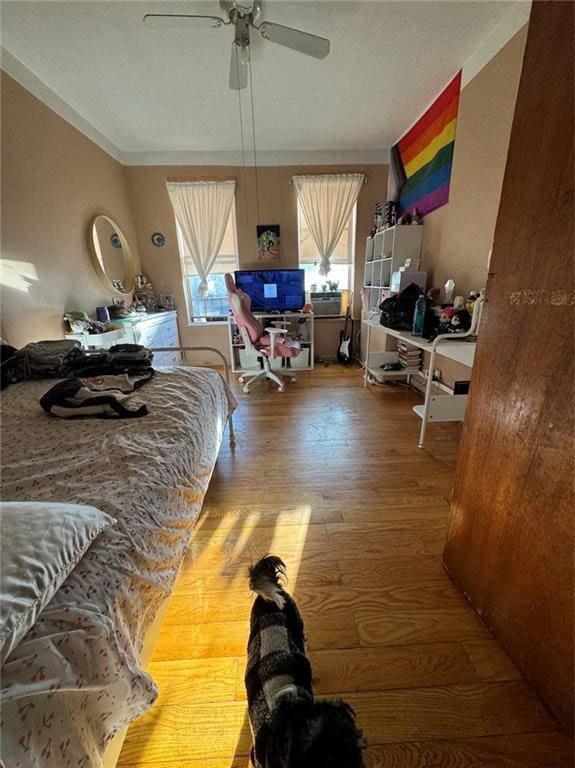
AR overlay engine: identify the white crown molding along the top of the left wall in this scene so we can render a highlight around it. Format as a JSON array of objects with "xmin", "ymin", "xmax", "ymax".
[{"xmin": 0, "ymin": 46, "xmax": 122, "ymax": 162}]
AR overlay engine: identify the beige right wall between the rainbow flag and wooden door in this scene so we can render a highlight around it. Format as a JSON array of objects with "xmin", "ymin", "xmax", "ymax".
[{"xmin": 422, "ymin": 25, "xmax": 528, "ymax": 296}]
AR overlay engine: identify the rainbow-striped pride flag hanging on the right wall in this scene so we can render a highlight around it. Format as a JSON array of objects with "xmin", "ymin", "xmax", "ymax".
[{"xmin": 391, "ymin": 70, "xmax": 461, "ymax": 216}]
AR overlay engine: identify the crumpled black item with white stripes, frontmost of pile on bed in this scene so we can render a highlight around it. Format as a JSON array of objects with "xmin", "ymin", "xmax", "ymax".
[{"xmin": 40, "ymin": 370, "xmax": 153, "ymax": 419}]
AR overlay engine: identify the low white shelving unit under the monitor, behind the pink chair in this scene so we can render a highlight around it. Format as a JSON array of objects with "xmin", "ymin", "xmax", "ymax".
[{"xmin": 228, "ymin": 312, "xmax": 314, "ymax": 374}]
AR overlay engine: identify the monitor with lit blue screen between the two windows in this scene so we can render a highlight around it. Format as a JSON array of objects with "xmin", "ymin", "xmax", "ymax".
[{"xmin": 235, "ymin": 269, "xmax": 305, "ymax": 312}]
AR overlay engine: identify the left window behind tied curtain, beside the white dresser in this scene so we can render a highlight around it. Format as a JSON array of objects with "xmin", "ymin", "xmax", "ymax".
[{"xmin": 176, "ymin": 205, "xmax": 238, "ymax": 323}]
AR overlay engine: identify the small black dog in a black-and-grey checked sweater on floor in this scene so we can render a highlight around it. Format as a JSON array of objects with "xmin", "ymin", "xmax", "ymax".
[{"xmin": 245, "ymin": 555, "xmax": 365, "ymax": 768}]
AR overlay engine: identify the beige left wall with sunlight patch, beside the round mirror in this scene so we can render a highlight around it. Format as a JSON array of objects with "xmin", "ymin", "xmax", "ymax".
[{"xmin": 1, "ymin": 73, "xmax": 140, "ymax": 346}]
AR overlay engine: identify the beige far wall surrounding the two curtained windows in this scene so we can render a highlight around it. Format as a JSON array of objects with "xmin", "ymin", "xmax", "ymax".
[{"xmin": 126, "ymin": 165, "xmax": 387, "ymax": 361}]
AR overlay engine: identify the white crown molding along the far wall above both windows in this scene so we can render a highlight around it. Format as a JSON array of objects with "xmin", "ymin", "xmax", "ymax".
[{"xmin": 122, "ymin": 149, "xmax": 389, "ymax": 167}]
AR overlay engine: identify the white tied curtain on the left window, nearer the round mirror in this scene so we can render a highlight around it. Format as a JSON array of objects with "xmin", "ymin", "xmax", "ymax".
[{"xmin": 166, "ymin": 181, "xmax": 236, "ymax": 296}]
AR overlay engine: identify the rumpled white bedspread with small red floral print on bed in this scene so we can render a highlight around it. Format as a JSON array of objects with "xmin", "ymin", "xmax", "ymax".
[{"xmin": 1, "ymin": 368, "xmax": 235, "ymax": 768}]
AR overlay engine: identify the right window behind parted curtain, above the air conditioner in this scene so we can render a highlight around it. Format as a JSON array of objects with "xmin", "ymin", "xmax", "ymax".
[{"xmin": 297, "ymin": 203, "xmax": 357, "ymax": 292}]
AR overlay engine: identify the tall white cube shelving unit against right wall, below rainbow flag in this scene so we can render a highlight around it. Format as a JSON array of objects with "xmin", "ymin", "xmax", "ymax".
[{"xmin": 363, "ymin": 224, "xmax": 423, "ymax": 312}]
